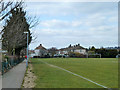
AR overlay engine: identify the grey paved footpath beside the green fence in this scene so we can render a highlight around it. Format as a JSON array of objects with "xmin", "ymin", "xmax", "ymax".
[{"xmin": 2, "ymin": 61, "xmax": 26, "ymax": 88}]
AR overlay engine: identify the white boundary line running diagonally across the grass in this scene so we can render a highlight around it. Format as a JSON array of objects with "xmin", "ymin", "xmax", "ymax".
[{"xmin": 40, "ymin": 60, "xmax": 108, "ymax": 88}]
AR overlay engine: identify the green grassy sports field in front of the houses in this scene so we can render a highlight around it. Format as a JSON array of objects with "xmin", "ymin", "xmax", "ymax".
[{"xmin": 31, "ymin": 58, "xmax": 118, "ymax": 88}]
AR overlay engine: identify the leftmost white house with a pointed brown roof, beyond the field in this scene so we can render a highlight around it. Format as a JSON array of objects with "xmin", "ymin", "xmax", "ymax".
[{"xmin": 35, "ymin": 44, "xmax": 48, "ymax": 57}]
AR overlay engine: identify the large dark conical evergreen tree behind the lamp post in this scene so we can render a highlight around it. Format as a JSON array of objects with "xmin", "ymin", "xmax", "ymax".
[{"xmin": 2, "ymin": 6, "xmax": 32, "ymax": 56}]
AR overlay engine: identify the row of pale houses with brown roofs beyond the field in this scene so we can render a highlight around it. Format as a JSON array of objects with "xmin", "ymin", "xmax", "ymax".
[{"xmin": 29, "ymin": 44, "xmax": 87, "ymax": 57}]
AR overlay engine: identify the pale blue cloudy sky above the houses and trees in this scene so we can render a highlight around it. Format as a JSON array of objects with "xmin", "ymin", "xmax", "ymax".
[{"xmin": 26, "ymin": 2, "xmax": 118, "ymax": 49}]
